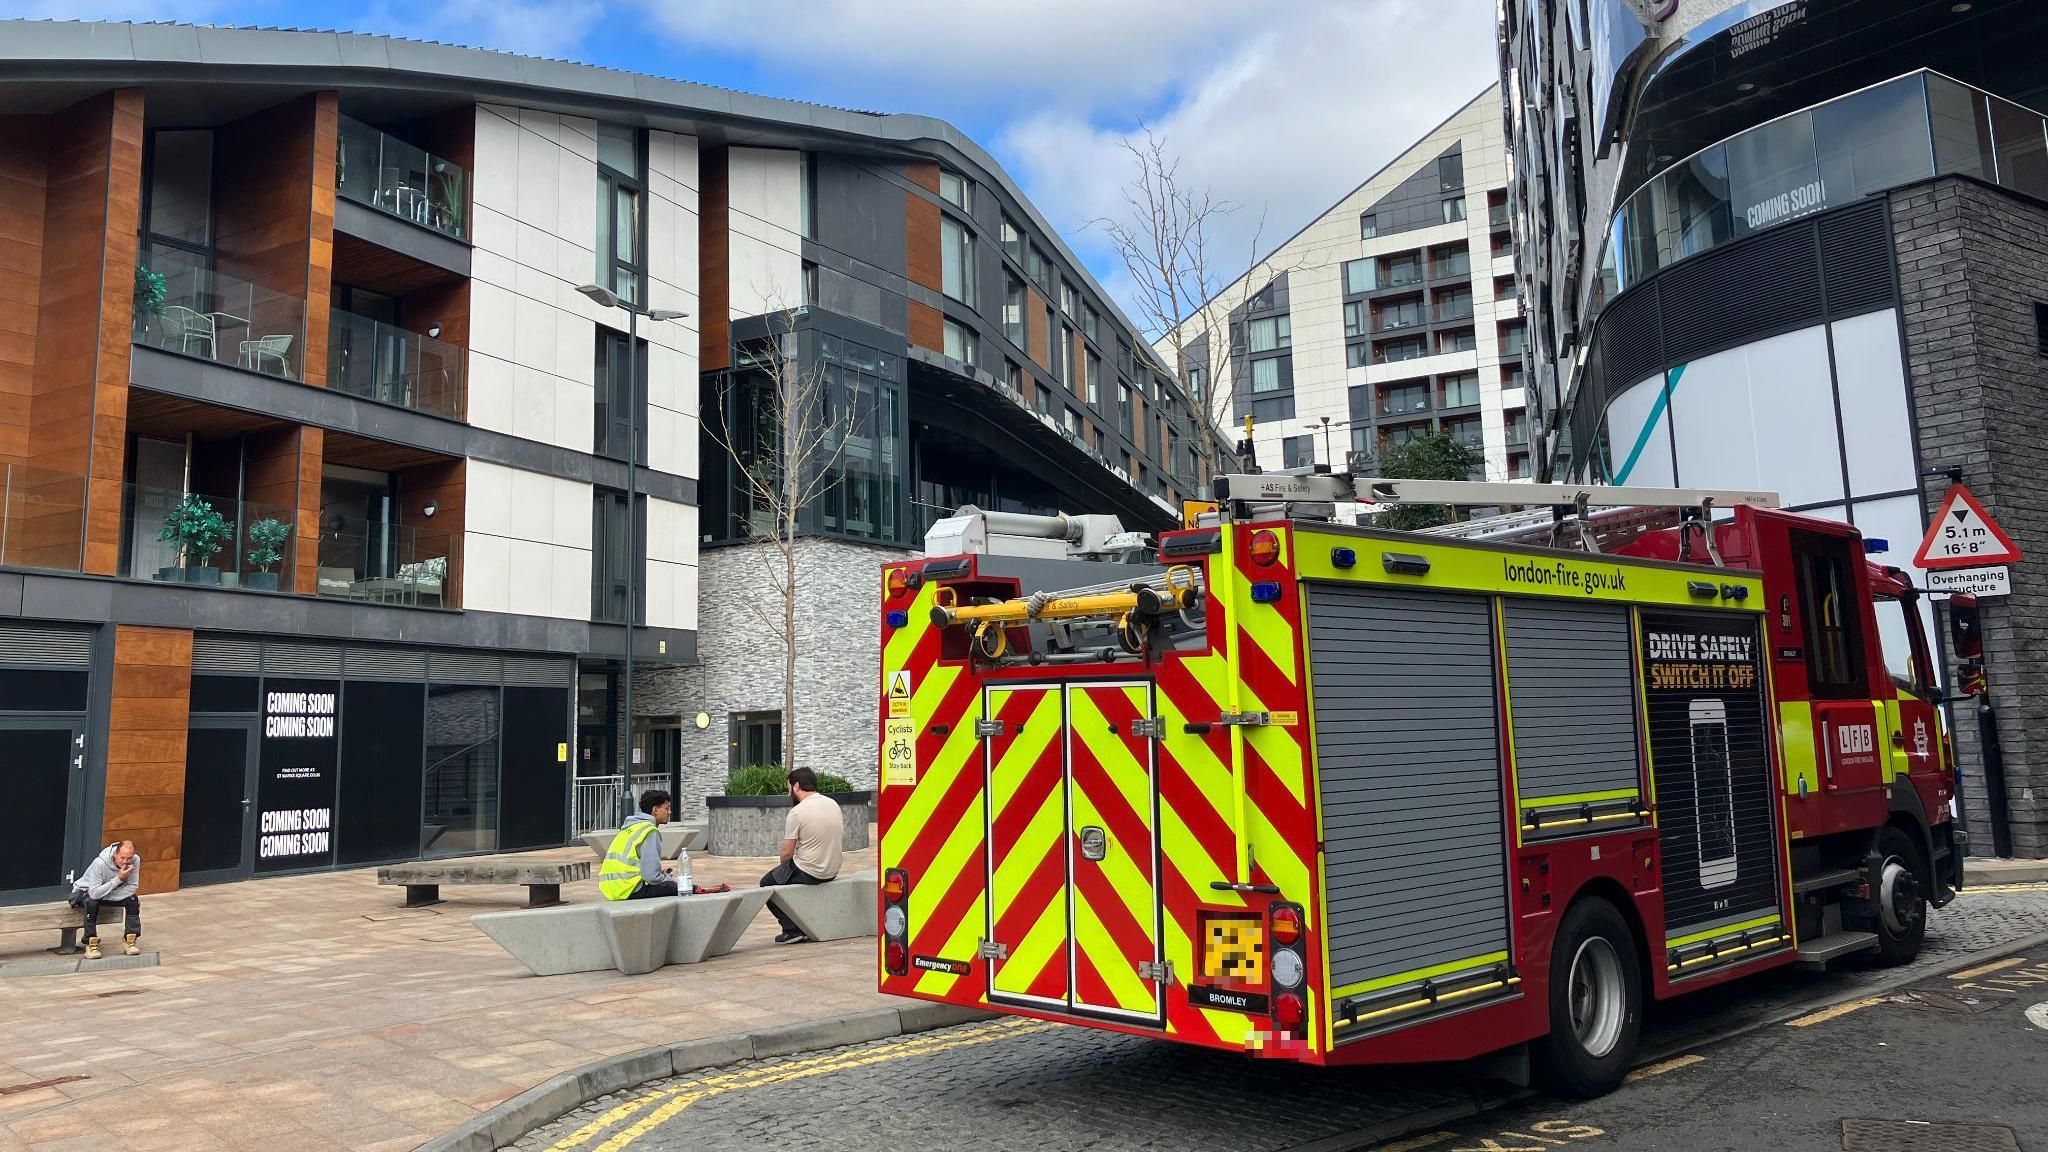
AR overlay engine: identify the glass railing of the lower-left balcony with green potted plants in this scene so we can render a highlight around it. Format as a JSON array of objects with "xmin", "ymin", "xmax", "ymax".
[{"xmin": 121, "ymin": 484, "xmax": 299, "ymax": 592}]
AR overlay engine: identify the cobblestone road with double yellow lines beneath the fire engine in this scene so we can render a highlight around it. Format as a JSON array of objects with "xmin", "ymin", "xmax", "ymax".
[{"xmin": 518, "ymin": 883, "xmax": 2048, "ymax": 1152}]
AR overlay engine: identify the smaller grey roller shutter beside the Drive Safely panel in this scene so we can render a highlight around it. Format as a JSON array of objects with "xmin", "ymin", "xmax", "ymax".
[{"xmin": 1505, "ymin": 601, "xmax": 1640, "ymax": 808}]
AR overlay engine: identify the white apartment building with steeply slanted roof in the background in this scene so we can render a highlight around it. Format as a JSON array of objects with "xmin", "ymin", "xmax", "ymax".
[{"xmin": 1155, "ymin": 88, "xmax": 1532, "ymax": 502}]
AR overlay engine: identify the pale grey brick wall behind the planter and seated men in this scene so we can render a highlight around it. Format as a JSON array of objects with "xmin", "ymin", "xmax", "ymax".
[{"xmin": 633, "ymin": 537, "xmax": 907, "ymax": 820}]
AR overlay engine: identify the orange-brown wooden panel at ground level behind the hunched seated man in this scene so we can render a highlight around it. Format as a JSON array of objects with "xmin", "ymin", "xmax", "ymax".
[{"xmin": 100, "ymin": 625, "xmax": 193, "ymax": 896}]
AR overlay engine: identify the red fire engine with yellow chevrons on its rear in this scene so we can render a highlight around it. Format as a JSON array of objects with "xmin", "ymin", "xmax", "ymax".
[{"xmin": 877, "ymin": 474, "xmax": 1964, "ymax": 1095}]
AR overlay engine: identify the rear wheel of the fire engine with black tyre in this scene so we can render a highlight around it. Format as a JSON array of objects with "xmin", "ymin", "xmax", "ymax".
[{"xmin": 1536, "ymin": 898, "xmax": 1642, "ymax": 1099}]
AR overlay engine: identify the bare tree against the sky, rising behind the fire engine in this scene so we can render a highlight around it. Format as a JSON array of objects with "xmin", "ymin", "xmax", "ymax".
[{"xmin": 1090, "ymin": 127, "xmax": 1278, "ymax": 474}]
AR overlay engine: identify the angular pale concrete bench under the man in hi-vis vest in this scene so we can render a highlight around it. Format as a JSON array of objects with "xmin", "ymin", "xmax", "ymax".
[{"xmin": 469, "ymin": 888, "xmax": 774, "ymax": 976}]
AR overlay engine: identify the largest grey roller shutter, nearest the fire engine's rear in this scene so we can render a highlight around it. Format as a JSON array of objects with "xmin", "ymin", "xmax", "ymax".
[{"xmin": 1307, "ymin": 584, "xmax": 1507, "ymax": 988}]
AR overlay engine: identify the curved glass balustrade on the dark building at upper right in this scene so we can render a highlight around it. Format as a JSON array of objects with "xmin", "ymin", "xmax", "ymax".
[{"xmin": 1602, "ymin": 72, "xmax": 2048, "ymax": 297}]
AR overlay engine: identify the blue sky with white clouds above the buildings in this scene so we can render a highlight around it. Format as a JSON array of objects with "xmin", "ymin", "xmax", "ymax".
[{"xmin": 0, "ymin": 0, "xmax": 1497, "ymax": 332}]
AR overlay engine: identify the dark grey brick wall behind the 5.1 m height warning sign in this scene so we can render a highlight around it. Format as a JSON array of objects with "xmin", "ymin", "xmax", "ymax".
[{"xmin": 1892, "ymin": 178, "xmax": 2048, "ymax": 857}]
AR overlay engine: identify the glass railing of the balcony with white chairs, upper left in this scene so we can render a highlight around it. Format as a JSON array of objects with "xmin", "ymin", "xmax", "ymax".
[{"xmin": 135, "ymin": 264, "xmax": 305, "ymax": 379}]
